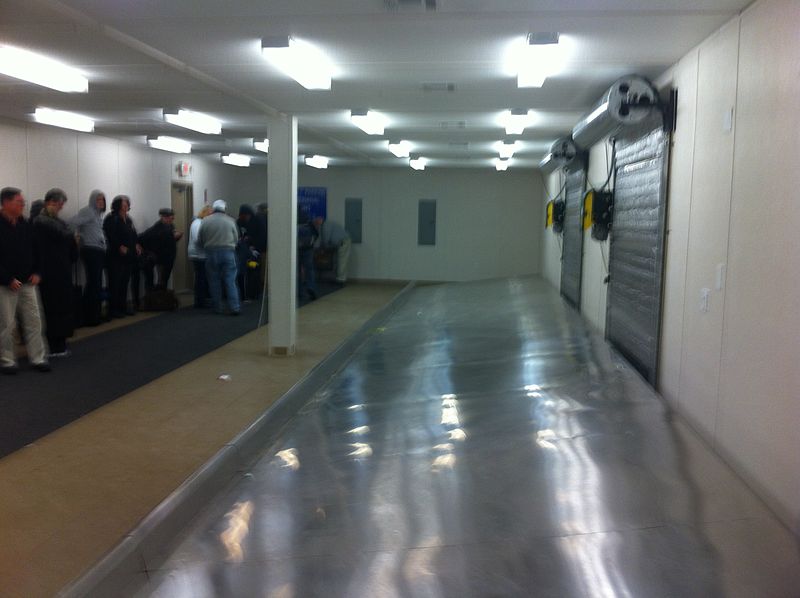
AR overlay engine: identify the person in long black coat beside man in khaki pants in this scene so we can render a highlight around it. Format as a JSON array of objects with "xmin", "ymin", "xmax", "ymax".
[{"xmin": 33, "ymin": 188, "xmax": 78, "ymax": 357}]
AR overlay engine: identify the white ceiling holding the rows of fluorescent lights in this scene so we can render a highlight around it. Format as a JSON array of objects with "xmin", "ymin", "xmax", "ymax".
[{"xmin": 0, "ymin": 0, "xmax": 750, "ymax": 168}]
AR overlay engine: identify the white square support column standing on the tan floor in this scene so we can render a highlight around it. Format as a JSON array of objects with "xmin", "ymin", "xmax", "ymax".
[{"xmin": 267, "ymin": 116, "xmax": 297, "ymax": 355}]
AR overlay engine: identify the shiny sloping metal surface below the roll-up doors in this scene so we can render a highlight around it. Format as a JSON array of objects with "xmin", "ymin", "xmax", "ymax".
[{"xmin": 140, "ymin": 279, "xmax": 800, "ymax": 598}]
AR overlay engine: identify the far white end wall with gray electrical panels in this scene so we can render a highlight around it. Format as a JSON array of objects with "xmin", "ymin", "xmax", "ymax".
[{"xmin": 298, "ymin": 167, "xmax": 543, "ymax": 281}]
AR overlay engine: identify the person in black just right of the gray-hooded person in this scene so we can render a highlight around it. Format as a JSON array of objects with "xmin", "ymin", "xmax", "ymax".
[{"xmin": 103, "ymin": 195, "xmax": 142, "ymax": 318}]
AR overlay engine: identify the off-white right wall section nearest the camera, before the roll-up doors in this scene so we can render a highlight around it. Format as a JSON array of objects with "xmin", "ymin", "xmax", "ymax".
[{"xmin": 659, "ymin": 0, "xmax": 800, "ymax": 532}]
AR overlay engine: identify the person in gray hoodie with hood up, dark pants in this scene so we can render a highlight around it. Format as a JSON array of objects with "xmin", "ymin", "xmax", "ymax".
[{"xmin": 70, "ymin": 189, "xmax": 106, "ymax": 326}]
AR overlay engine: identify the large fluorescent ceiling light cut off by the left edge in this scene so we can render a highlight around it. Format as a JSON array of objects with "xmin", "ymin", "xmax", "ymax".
[{"xmin": 0, "ymin": 46, "xmax": 89, "ymax": 93}]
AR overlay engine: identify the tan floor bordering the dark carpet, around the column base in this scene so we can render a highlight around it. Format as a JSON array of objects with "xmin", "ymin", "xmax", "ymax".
[{"xmin": 0, "ymin": 284, "xmax": 403, "ymax": 598}]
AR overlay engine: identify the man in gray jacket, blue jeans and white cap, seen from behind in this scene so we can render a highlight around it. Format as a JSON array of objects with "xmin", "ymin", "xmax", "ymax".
[{"xmin": 197, "ymin": 199, "xmax": 242, "ymax": 316}]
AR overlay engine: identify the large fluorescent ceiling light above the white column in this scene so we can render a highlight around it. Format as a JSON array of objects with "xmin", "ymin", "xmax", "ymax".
[{"xmin": 261, "ymin": 35, "xmax": 334, "ymax": 89}]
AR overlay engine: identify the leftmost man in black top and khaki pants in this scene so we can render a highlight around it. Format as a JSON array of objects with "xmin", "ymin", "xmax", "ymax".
[{"xmin": 0, "ymin": 187, "xmax": 50, "ymax": 374}]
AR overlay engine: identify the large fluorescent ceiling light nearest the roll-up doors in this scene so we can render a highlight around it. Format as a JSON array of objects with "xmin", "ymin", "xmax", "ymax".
[{"xmin": 505, "ymin": 31, "xmax": 570, "ymax": 87}]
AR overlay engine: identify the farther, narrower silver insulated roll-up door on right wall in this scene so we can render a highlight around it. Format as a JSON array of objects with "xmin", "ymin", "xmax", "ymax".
[{"xmin": 561, "ymin": 165, "xmax": 586, "ymax": 309}]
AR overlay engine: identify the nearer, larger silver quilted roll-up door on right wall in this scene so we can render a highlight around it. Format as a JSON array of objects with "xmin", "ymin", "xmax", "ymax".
[{"xmin": 606, "ymin": 127, "xmax": 669, "ymax": 384}]
